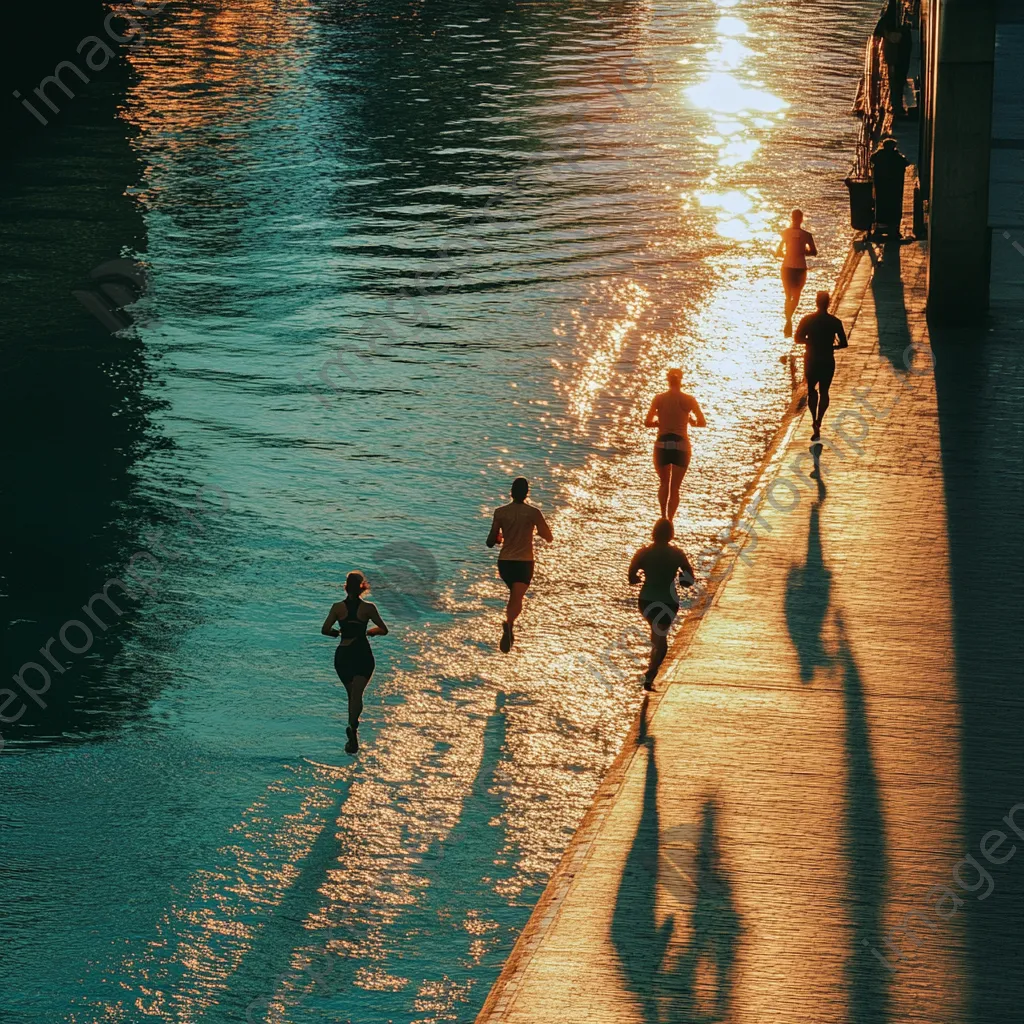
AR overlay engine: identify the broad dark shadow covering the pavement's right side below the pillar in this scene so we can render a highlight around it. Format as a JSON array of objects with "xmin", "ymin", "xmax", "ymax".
[{"xmin": 930, "ymin": 321, "xmax": 1024, "ymax": 1024}]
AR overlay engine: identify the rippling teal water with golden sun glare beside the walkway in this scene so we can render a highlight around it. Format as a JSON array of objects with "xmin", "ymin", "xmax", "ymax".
[{"xmin": 0, "ymin": 0, "xmax": 876, "ymax": 1024}]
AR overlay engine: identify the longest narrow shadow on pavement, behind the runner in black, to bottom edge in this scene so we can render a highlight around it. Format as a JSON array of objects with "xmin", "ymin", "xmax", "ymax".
[{"xmin": 785, "ymin": 491, "xmax": 890, "ymax": 1024}]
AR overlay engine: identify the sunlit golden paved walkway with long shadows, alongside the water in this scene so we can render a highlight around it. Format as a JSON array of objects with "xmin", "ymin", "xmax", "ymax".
[{"xmin": 478, "ymin": 205, "xmax": 1024, "ymax": 1024}]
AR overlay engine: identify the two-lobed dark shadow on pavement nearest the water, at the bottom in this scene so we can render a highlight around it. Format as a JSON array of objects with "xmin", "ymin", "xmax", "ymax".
[{"xmin": 611, "ymin": 737, "xmax": 740, "ymax": 1024}]
